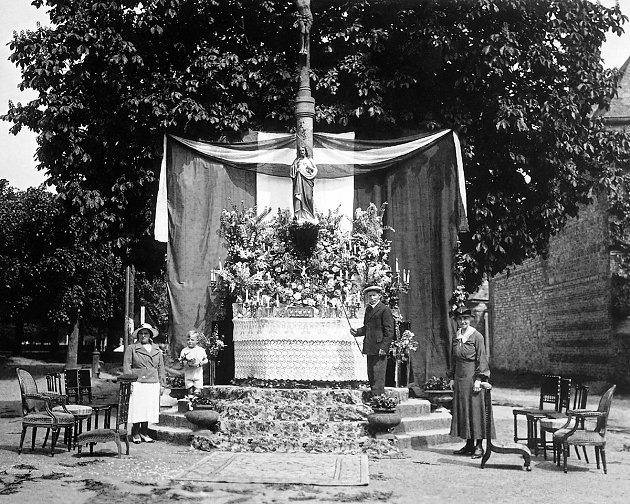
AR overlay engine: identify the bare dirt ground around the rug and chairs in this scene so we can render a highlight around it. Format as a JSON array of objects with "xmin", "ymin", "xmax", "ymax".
[{"xmin": 0, "ymin": 357, "xmax": 630, "ymax": 504}]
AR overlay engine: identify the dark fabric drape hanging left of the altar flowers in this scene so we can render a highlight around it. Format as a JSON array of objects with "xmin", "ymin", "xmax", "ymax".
[{"xmin": 167, "ymin": 142, "xmax": 256, "ymax": 355}]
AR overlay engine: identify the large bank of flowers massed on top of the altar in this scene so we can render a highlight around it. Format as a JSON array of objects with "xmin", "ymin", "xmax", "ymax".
[{"xmin": 218, "ymin": 200, "xmax": 408, "ymax": 315}]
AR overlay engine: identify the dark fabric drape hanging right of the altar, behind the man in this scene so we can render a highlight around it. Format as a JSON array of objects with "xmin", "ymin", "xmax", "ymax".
[{"xmin": 355, "ymin": 137, "xmax": 466, "ymax": 384}]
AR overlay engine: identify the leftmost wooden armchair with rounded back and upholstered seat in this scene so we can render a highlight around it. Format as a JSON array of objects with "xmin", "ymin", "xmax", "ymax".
[{"xmin": 16, "ymin": 368, "xmax": 74, "ymax": 457}]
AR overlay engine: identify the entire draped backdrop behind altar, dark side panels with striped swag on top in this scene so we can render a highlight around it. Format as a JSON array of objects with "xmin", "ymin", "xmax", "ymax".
[{"xmin": 155, "ymin": 130, "xmax": 467, "ymax": 383}]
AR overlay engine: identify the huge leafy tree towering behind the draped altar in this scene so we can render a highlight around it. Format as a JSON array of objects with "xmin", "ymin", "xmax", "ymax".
[{"xmin": 4, "ymin": 0, "xmax": 628, "ymax": 288}]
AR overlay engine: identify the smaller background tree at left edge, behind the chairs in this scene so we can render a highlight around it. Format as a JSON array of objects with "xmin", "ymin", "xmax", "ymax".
[{"xmin": 0, "ymin": 180, "xmax": 129, "ymax": 360}]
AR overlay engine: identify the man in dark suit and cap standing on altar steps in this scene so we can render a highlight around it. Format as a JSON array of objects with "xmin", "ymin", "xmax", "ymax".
[{"xmin": 350, "ymin": 285, "xmax": 394, "ymax": 396}]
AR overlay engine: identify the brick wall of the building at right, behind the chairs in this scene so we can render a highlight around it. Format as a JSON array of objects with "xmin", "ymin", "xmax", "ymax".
[{"xmin": 490, "ymin": 197, "xmax": 619, "ymax": 380}]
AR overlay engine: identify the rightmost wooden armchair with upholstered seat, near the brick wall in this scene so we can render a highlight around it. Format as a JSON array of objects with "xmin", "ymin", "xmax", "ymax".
[{"xmin": 553, "ymin": 385, "xmax": 617, "ymax": 474}]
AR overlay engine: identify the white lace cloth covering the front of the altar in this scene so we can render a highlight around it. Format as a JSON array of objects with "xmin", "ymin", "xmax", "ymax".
[{"xmin": 234, "ymin": 318, "xmax": 367, "ymax": 381}]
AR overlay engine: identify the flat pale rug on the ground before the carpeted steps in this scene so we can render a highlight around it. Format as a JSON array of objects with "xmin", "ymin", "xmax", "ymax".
[{"xmin": 172, "ymin": 452, "xmax": 370, "ymax": 486}]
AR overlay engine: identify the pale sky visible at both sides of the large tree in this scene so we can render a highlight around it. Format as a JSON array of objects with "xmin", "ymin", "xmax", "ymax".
[{"xmin": 0, "ymin": 0, "xmax": 630, "ymax": 190}]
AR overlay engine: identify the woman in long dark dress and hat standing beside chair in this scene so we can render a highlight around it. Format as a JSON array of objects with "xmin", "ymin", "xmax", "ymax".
[{"xmin": 448, "ymin": 310, "xmax": 490, "ymax": 458}]
